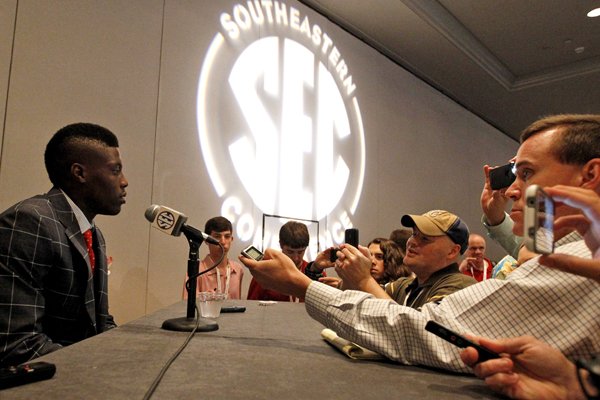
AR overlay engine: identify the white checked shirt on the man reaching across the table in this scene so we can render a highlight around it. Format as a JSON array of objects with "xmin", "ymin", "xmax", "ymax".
[{"xmin": 306, "ymin": 233, "xmax": 600, "ymax": 372}]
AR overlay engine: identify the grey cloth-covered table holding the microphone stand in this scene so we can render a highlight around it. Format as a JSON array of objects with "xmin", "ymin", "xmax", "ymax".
[{"xmin": 0, "ymin": 300, "xmax": 500, "ymax": 400}]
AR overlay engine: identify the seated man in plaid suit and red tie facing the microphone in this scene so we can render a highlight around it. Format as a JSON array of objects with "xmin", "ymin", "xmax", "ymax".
[{"xmin": 0, "ymin": 123, "xmax": 128, "ymax": 366}]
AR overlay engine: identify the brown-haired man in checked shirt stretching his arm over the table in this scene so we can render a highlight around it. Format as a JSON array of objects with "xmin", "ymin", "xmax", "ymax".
[{"xmin": 243, "ymin": 115, "xmax": 600, "ymax": 372}]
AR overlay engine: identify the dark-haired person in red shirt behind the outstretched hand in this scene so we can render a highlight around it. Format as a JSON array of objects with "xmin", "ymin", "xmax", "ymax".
[{"xmin": 248, "ymin": 221, "xmax": 325, "ymax": 301}]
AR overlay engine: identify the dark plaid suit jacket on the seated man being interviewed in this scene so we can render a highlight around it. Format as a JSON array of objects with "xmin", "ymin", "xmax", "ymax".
[{"xmin": 0, "ymin": 188, "xmax": 115, "ymax": 366}]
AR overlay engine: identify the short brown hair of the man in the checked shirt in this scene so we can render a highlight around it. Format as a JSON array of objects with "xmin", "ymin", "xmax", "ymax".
[{"xmin": 521, "ymin": 114, "xmax": 600, "ymax": 165}]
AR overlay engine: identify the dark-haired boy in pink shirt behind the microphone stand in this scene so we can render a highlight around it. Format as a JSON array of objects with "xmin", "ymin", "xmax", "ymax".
[{"xmin": 183, "ymin": 216, "xmax": 244, "ymax": 299}]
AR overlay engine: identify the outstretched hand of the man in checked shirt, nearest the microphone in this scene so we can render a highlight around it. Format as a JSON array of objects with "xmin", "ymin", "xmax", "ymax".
[{"xmin": 239, "ymin": 249, "xmax": 312, "ymax": 299}]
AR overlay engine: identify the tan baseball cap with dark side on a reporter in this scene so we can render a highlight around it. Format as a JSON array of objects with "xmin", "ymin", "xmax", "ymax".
[{"xmin": 401, "ymin": 210, "xmax": 469, "ymax": 254}]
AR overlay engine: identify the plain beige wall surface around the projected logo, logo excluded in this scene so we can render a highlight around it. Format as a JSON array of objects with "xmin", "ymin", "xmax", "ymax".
[{"xmin": 0, "ymin": 0, "xmax": 517, "ymax": 323}]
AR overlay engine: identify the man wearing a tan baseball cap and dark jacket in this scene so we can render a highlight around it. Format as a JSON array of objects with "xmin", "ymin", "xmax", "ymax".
[{"xmin": 385, "ymin": 210, "xmax": 477, "ymax": 309}]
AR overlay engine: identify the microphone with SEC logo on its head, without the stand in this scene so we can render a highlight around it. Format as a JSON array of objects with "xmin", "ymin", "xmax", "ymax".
[{"xmin": 144, "ymin": 204, "xmax": 220, "ymax": 246}]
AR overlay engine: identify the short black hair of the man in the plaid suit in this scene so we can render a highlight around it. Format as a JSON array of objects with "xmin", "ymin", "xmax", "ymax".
[{"xmin": 44, "ymin": 122, "xmax": 119, "ymax": 187}]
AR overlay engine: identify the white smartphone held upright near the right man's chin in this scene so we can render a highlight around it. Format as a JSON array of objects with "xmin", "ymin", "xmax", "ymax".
[{"xmin": 523, "ymin": 185, "xmax": 554, "ymax": 254}]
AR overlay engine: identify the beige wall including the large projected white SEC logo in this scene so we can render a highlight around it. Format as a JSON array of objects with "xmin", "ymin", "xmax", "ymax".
[{"xmin": 0, "ymin": 0, "xmax": 517, "ymax": 322}]
